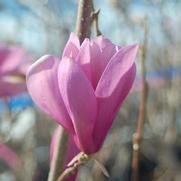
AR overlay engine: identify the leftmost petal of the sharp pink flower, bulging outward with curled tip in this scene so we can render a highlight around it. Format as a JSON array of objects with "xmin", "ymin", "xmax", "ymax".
[{"xmin": 27, "ymin": 55, "xmax": 74, "ymax": 133}]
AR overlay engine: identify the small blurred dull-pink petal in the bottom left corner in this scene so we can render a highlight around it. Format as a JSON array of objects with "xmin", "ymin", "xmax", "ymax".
[{"xmin": 0, "ymin": 143, "xmax": 20, "ymax": 169}]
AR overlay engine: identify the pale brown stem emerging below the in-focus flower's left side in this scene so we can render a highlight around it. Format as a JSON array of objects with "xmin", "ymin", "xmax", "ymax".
[{"xmin": 48, "ymin": 127, "xmax": 68, "ymax": 181}]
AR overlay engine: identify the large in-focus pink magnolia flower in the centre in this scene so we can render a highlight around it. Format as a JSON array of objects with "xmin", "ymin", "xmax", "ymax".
[{"xmin": 27, "ymin": 34, "xmax": 138, "ymax": 154}]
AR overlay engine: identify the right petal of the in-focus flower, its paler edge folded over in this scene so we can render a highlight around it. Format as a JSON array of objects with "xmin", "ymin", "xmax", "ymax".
[{"xmin": 94, "ymin": 45, "xmax": 138, "ymax": 149}]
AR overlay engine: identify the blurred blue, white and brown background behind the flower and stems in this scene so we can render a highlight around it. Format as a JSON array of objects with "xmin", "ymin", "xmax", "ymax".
[{"xmin": 0, "ymin": 0, "xmax": 181, "ymax": 181}]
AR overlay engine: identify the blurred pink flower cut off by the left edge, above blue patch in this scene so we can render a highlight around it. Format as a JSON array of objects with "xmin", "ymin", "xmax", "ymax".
[{"xmin": 0, "ymin": 45, "xmax": 31, "ymax": 97}]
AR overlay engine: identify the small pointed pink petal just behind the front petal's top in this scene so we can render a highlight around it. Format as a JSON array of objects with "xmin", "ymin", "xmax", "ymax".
[{"xmin": 76, "ymin": 38, "xmax": 91, "ymax": 80}]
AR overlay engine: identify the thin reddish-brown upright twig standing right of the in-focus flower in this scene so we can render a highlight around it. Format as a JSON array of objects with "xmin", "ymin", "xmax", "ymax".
[{"xmin": 131, "ymin": 19, "xmax": 148, "ymax": 181}]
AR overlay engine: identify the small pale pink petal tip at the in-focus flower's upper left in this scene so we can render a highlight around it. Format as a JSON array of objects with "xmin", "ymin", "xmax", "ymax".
[{"xmin": 62, "ymin": 33, "xmax": 80, "ymax": 59}]
